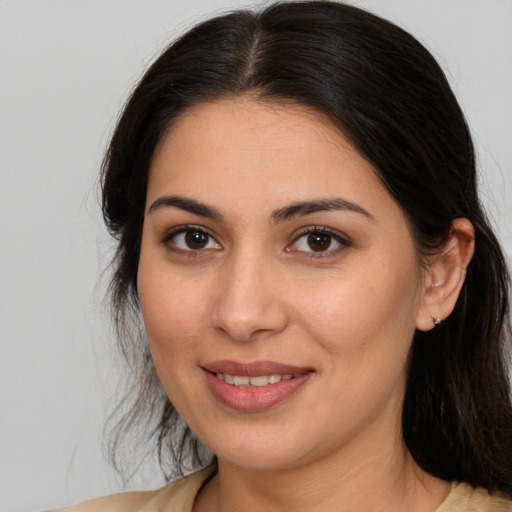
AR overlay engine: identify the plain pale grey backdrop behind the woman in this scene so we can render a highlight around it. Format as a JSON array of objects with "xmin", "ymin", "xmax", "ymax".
[{"xmin": 0, "ymin": 0, "xmax": 512, "ymax": 512}]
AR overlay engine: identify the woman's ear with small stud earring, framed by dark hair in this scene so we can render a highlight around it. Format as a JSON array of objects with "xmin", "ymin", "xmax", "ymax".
[{"xmin": 416, "ymin": 218, "xmax": 475, "ymax": 331}]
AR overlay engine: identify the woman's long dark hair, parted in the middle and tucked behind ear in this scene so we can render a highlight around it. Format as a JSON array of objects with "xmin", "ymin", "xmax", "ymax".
[{"xmin": 102, "ymin": 1, "xmax": 512, "ymax": 493}]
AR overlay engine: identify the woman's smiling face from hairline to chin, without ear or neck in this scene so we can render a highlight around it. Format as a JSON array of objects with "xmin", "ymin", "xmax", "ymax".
[{"xmin": 138, "ymin": 98, "xmax": 425, "ymax": 469}]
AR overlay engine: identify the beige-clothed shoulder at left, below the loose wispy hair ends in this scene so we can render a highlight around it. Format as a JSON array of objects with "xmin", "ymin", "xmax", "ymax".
[{"xmin": 42, "ymin": 467, "xmax": 214, "ymax": 512}]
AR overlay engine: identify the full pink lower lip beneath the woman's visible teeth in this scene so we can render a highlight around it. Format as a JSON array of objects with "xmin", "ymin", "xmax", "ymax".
[{"xmin": 204, "ymin": 370, "xmax": 313, "ymax": 412}]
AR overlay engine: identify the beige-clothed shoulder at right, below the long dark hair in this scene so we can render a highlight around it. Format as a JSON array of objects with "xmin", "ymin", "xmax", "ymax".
[{"xmin": 436, "ymin": 482, "xmax": 512, "ymax": 512}]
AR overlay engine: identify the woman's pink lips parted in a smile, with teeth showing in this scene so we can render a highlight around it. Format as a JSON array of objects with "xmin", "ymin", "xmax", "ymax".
[{"xmin": 202, "ymin": 361, "xmax": 314, "ymax": 412}]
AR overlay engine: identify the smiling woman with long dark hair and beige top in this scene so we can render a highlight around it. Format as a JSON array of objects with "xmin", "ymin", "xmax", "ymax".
[{"xmin": 50, "ymin": 2, "xmax": 512, "ymax": 512}]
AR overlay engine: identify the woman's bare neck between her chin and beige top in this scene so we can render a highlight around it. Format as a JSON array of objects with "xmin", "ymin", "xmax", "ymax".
[{"xmin": 194, "ymin": 430, "xmax": 449, "ymax": 512}]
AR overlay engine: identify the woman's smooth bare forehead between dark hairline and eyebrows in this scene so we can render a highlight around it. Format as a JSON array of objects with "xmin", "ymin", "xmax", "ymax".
[{"xmin": 148, "ymin": 97, "xmax": 397, "ymax": 223}]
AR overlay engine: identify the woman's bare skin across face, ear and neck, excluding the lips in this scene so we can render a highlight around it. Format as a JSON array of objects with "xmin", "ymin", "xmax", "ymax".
[{"xmin": 138, "ymin": 97, "xmax": 472, "ymax": 512}]
